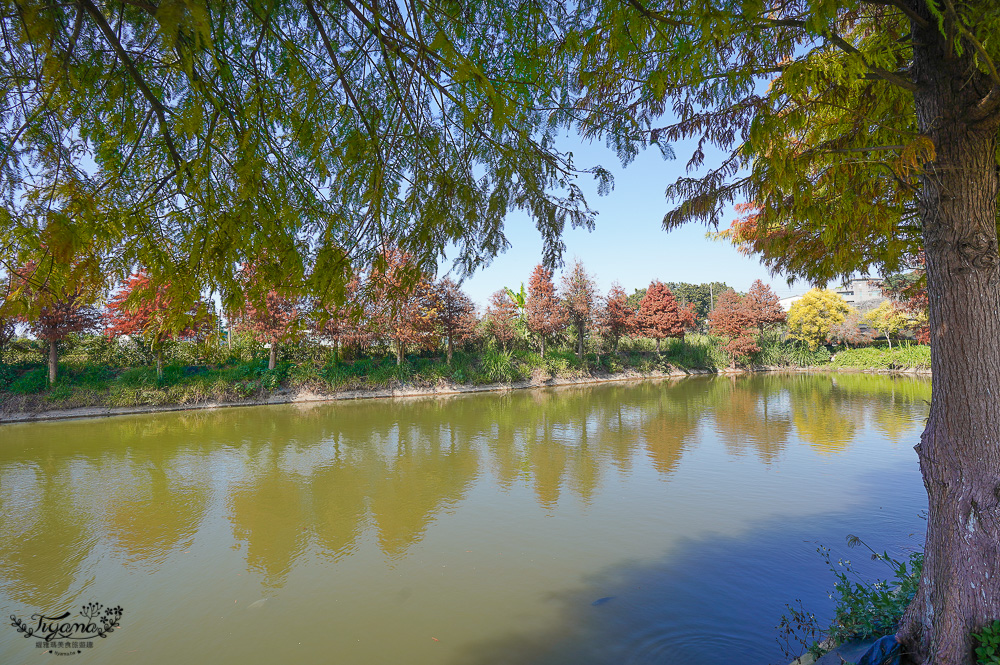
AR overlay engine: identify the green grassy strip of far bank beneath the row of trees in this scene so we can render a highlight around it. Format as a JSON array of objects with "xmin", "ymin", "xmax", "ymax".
[{"xmin": 0, "ymin": 334, "xmax": 930, "ymax": 413}]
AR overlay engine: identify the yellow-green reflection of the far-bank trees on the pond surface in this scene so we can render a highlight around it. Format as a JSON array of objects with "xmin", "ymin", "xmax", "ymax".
[{"xmin": 0, "ymin": 375, "xmax": 930, "ymax": 652}]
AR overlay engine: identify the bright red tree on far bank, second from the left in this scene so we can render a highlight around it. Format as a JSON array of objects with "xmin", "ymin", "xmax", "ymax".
[{"xmin": 104, "ymin": 272, "xmax": 215, "ymax": 378}]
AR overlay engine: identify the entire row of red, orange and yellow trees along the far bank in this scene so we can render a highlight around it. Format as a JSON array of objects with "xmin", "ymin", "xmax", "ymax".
[{"xmin": 0, "ymin": 250, "xmax": 926, "ymax": 383}]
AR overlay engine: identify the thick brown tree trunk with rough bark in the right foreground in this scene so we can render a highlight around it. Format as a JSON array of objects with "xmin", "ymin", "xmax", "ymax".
[{"xmin": 899, "ymin": 2, "xmax": 1000, "ymax": 665}]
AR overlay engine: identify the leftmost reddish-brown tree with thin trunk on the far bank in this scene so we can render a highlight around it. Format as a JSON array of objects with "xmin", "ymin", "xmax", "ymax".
[{"xmin": 11, "ymin": 262, "xmax": 101, "ymax": 385}]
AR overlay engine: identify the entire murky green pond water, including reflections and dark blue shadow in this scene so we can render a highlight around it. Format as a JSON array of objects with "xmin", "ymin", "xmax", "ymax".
[{"xmin": 0, "ymin": 375, "xmax": 930, "ymax": 665}]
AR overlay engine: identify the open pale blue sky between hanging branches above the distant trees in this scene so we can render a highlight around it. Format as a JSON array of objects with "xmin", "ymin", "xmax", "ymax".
[{"xmin": 446, "ymin": 137, "xmax": 809, "ymax": 307}]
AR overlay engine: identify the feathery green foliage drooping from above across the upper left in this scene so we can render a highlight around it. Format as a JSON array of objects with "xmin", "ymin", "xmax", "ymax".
[{"xmin": 0, "ymin": 2, "xmax": 611, "ymax": 305}]
